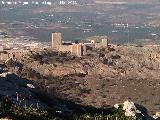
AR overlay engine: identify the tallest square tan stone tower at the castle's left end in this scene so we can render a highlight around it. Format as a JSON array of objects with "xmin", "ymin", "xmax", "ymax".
[{"xmin": 52, "ymin": 33, "xmax": 62, "ymax": 47}]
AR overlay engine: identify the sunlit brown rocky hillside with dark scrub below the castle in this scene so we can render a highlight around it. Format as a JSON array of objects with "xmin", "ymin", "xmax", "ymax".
[{"xmin": 3, "ymin": 45, "xmax": 160, "ymax": 113}]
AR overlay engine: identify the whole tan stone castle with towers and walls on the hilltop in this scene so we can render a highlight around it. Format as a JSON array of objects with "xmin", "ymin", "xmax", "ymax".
[{"xmin": 52, "ymin": 33, "xmax": 108, "ymax": 57}]
